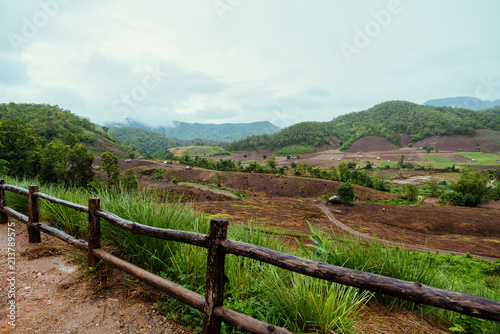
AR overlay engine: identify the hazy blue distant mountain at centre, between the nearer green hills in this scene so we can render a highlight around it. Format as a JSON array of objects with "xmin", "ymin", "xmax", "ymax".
[{"xmin": 110, "ymin": 119, "xmax": 280, "ymax": 142}]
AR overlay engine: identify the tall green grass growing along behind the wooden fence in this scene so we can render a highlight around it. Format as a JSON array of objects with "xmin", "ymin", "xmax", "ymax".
[{"xmin": 1, "ymin": 178, "xmax": 500, "ymax": 333}]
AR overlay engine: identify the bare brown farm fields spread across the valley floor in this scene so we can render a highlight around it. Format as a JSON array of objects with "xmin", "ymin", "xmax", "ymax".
[{"xmin": 102, "ymin": 154, "xmax": 500, "ymax": 260}]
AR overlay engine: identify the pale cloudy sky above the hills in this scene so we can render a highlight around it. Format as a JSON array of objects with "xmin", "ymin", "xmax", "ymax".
[{"xmin": 0, "ymin": 0, "xmax": 500, "ymax": 127}]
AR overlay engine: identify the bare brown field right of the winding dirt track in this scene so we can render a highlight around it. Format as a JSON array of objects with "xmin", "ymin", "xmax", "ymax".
[{"xmin": 334, "ymin": 203, "xmax": 500, "ymax": 258}]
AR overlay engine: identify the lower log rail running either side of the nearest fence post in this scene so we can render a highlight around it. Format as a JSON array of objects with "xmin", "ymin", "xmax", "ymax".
[{"xmin": 92, "ymin": 248, "xmax": 291, "ymax": 334}]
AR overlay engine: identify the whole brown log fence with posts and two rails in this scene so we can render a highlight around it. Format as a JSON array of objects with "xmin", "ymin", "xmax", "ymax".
[{"xmin": 0, "ymin": 180, "xmax": 500, "ymax": 334}]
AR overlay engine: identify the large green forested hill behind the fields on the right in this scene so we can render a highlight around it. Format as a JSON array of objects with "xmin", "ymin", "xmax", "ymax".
[{"xmin": 226, "ymin": 101, "xmax": 500, "ymax": 151}]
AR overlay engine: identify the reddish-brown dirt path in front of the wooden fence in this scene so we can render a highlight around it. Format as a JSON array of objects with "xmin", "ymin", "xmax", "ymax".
[{"xmin": 0, "ymin": 223, "xmax": 189, "ymax": 334}]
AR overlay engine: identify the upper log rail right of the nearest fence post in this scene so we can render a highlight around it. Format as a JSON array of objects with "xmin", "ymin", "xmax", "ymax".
[{"xmin": 221, "ymin": 239, "xmax": 500, "ymax": 322}]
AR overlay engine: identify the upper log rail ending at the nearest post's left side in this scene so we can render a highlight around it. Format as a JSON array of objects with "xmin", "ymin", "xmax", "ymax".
[{"xmin": 95, "ymin": 210, "xmax": 208, "ymax": 248}]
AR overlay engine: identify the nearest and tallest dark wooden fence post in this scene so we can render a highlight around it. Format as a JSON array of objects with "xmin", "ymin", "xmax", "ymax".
[{"xmin": 202, "ymin": 218, "xmax": 228, "ymax": 334}]
